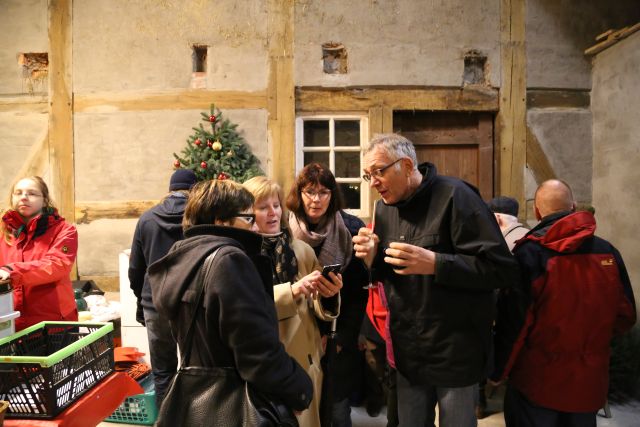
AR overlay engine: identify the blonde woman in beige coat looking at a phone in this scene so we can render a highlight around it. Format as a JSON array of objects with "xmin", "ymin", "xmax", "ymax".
[{"xmin": 244, "ymin": 176, "xmax": 342, "ymax": 427}]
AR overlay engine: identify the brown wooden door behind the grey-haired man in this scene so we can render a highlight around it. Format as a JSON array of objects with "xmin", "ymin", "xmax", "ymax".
[{"xmin": 393, "ymin": 111, "xmax": 493, "ymax": 200}]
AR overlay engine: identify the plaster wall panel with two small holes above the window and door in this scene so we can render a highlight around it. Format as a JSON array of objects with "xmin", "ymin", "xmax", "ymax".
[{"xmin": 294, "ymin": 0, "xmax": 500, "ymax": 86}]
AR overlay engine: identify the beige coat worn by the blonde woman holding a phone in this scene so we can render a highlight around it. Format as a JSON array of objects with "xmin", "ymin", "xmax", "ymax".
[{"xmin": 273, "ymin": 239, "xmax": 340, "ymax": 427}]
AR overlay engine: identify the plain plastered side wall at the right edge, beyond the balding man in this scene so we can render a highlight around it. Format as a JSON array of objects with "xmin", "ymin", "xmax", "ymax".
[{"xmin": 591, "ymin": 32, "xmax": 640, "ymax": 306}]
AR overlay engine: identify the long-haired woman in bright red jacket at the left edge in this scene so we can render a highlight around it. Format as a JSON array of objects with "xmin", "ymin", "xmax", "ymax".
[{"xmin": 0, "ymin": 176, "xmax": 78, "ymax": 331}]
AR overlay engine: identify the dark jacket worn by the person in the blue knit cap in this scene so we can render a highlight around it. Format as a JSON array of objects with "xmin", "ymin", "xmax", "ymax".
[{"xmin": 129, "ymin": 192, "xmax": 187, "ymax": 324}]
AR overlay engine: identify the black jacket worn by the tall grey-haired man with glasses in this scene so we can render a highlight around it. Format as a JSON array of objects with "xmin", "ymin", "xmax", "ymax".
[{"xmin": 374, "ymin": 163, "xmax": 518, "ymax": 387}]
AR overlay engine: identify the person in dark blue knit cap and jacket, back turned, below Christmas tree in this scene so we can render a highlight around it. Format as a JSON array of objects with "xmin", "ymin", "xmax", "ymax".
[{"xmin": 129, "ymin": 169, "xmax": 196, "ymax": 407}]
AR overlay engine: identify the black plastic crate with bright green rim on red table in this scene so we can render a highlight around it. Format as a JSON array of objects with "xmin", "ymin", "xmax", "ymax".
[{"xmin": 0, "ymin": 322, "xmax": 114, "ymax": 419}]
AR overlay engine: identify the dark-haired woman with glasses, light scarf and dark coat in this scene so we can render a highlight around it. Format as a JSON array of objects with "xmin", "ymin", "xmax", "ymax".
[{"xmin": 287, "ymin": 163, "xmax": 369, "ymax": 427}]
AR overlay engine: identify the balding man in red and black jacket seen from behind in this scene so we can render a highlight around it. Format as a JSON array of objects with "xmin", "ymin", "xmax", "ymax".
[{"xmin": 492, "ymin": 180, "xmax": 636, "ymax": 427}]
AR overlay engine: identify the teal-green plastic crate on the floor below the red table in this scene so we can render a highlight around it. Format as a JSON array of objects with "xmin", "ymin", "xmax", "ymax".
[{"xmin": 105, "ymin": 374, "xmax": 158, "ymax": 425}]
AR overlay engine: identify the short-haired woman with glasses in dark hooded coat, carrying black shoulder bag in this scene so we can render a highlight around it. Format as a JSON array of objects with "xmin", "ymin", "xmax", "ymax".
[{"xmin": 148, "ymin": 180, "xmax": 313, "ymax": 424}]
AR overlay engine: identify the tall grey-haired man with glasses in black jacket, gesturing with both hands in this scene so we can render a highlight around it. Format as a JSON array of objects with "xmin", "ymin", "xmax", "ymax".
[{"xmin": 353, "ymin": 134, "xmax": 517, "ymax": 427}]
